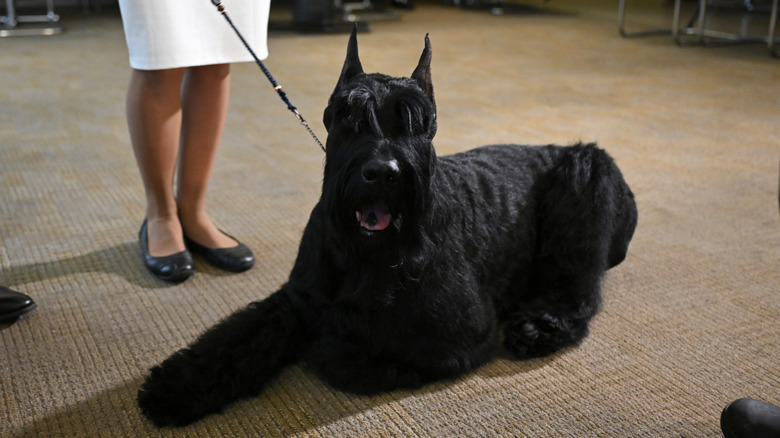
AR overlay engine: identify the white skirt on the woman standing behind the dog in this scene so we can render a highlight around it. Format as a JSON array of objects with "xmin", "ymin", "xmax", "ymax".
[{"xmin": 119, "ymin": 0, "xmax": 271, "ymax": 70}]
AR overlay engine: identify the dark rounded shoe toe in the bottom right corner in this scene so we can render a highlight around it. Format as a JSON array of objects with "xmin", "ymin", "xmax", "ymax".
[{"xmin": 720, "ymin": 398, "xmax": 780, "ymax": 438}]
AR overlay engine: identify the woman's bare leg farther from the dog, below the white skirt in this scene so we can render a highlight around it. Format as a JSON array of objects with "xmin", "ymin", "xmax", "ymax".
[{"xmin": 126, "ymin": 68, "xmax": 190, "ymax": 257}]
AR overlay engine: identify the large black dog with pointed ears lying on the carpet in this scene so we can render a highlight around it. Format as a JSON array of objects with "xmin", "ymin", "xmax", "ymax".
[{"xmin": 138, "ymin": 32, "xmax": 637, "ymax": 426}]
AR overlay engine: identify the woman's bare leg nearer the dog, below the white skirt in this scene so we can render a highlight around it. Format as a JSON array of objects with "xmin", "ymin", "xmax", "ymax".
[{"xmin": 176, "ymin": 64, "xmax": 238, "ymax": 248}]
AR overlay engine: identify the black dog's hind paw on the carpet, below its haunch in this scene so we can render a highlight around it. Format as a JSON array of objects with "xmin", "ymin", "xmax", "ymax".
[{"xmin": 504, "ymin": 313, "xmax": 587, "ymax": 359}]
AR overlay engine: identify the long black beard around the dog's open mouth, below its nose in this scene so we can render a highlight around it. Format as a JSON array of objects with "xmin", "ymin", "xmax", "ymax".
[{"xmin": 321, "ymin": 142, "xmax": 435, "ymax": 280}]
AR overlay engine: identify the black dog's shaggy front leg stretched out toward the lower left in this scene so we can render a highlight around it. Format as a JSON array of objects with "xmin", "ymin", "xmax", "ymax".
[{"xmin": 138, "ymin": 289, "xmax": 303, "ymax": 427}]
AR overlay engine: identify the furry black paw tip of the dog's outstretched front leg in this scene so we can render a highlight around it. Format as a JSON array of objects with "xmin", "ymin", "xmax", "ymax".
[{"xmin": 138, "ymin": 350, "xmax": 219, "ymax": 427}]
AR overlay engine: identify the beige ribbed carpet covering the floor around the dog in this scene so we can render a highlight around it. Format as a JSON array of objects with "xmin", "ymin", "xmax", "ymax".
[{"xmin": 0, "ymin": 0, "xmax": 780, "ymax": 437}]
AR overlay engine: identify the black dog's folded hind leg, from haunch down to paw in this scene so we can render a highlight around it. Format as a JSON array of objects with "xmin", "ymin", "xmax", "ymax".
[{"xmin": 503, "ymin": 145, "xmax": 636, "ymax": 358}]
